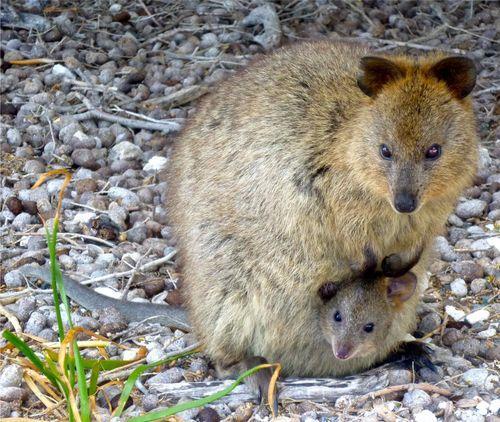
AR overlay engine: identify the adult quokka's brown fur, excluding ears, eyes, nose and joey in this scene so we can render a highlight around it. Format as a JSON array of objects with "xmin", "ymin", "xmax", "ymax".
[{"xmin": 167, "ymin": 41, "xmax": 477, "ymax": 376}]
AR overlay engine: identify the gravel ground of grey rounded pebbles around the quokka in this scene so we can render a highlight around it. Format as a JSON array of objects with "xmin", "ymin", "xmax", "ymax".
[{"xmin": 0, "ymin": 0, "xmax": 500, "ymax": 422}]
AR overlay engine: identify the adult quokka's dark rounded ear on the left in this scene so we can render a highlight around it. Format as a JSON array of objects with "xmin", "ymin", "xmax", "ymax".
[{"xmin": 357, "ymin": 56, "xmax": 405, "ymax": 97}]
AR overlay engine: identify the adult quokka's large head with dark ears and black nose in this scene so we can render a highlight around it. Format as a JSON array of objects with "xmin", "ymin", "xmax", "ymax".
[{"xmin": 351, "ymin": 56, "xmax": 477, "ymax": 213}]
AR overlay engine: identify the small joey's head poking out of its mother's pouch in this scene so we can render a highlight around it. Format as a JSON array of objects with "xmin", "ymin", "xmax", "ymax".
[{"xmin": 318, "ymin": 251, "xmax": 417, "ymax": 360}]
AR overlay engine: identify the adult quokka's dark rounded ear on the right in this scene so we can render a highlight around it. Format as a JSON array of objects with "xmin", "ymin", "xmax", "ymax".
[{"xmin": 430, "ymin": 56, "xmax": 476, "ymax": 99}]
